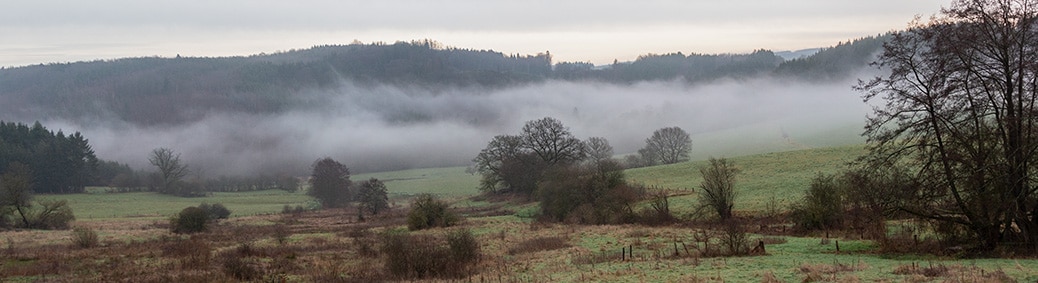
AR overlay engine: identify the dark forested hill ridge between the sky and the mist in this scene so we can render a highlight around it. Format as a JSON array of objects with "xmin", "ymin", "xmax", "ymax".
[{"xmin": 0, "ymin": 37, "xmax": 882, "ymax": 125}]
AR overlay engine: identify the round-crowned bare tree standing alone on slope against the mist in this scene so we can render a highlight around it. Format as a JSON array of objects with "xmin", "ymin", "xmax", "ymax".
[{"xmin": 638, "ymin": 126, "xmax": 692, "ymax": 165}]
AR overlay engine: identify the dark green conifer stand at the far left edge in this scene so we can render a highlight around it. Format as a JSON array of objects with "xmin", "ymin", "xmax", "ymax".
[{"xmin": 0, "ymin": 121, "xmax": 98, "ymax": 193}]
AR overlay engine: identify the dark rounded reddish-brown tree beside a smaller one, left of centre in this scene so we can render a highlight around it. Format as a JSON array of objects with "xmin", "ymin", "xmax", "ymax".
[{"xmin": 306, "ymin": 158, "xmax": 351, "ymax": 208}]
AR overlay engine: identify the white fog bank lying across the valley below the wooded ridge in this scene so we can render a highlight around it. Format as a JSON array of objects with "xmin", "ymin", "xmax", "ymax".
[{"xmin": 42, "ymin": 79, "xmax": 868, "ymax": 176}]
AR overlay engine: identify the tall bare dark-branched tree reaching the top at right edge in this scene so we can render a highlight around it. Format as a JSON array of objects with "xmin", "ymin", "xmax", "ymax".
[{"xmin": 857, "ymin": 0, "xmax": 1038, "ymax": 251}]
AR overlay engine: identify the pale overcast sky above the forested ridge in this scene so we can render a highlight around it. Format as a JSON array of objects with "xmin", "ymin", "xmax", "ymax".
[{"xmin": 0, "ymin": 0, "xmax": 950, "ymax": 66}]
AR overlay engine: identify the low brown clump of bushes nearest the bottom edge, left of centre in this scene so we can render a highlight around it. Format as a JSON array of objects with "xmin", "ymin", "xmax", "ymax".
[{"xmin": 382, "ymin": 229, "xmax": 482, "ymax": 279}]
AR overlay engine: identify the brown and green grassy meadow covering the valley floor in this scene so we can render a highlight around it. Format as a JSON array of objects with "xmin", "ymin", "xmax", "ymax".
[{"xmin": 8, "ymin": 146, "xmax": 1038, "ymax": 282}]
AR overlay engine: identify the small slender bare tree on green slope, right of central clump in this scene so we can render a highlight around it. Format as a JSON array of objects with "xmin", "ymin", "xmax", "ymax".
[{"xmin": 700, "ymin": 158, "xmax": 739, "ymax": 220}]
